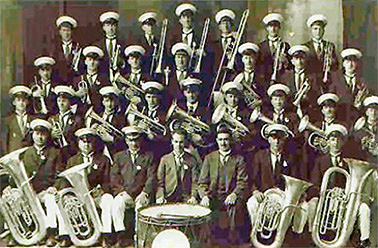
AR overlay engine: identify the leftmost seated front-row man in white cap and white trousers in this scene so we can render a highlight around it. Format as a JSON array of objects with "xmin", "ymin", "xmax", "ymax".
[{"xmin": 20, "ymin": 119, "xmax": 68, "ymax": 247}]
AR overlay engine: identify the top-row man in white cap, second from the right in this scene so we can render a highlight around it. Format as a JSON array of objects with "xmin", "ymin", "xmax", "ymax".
[{"xmin": 259, "ymin": 13, "xmax": 290, "ymax": 82}]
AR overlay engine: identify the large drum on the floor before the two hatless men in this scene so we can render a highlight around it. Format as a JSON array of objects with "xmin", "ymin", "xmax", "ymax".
[{"xmin": 136, "ymin": 203, "xmax": 211, "ymax": 247}]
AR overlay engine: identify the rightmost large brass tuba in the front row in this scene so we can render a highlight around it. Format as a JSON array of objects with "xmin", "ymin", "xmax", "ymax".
[{"xmin": 312, "ymin": 158, "xmax": 375, "ymax": 248}]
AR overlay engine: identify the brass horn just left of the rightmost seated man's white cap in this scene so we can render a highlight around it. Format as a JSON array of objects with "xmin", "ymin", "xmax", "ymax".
[{"xmin": 298, "ymin": 115, "xmax": 329, "ymax": 153}]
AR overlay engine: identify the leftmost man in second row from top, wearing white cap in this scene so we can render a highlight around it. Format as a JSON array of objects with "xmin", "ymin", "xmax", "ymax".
[{"xmin": 30, "ymin": 56, "xmax": 57, "ymax": 118}]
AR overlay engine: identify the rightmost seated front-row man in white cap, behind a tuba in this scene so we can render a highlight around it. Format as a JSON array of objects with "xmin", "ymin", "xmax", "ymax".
[{"xmin": 307, "ymin": 124, "xmax": 372, "ymax": 248}]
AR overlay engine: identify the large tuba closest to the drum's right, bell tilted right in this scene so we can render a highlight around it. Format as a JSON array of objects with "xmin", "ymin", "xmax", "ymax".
[{"xmin": 251, "ymin": 175, "xmax": 312, "ymax": 248}]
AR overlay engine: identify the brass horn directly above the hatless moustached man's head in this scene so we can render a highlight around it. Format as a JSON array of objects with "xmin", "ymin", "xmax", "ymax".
[{"xmin": 211, "ymin": 104, "xmax": 249, "ymax": 137}]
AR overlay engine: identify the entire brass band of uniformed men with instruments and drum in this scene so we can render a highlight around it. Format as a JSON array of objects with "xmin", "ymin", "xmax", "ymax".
[{"xmin": 0, "ymin": 3, "xmax": 378, "ymax": 248}]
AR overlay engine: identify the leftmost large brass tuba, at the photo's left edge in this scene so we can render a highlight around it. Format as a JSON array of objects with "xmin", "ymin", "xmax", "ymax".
[{"xmin": 0, "ymin": 147, "xmax": 46, "ymax": 246}]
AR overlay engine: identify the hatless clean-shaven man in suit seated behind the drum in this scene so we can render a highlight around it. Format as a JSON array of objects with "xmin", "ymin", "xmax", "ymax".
[{"xmin": 156, "ymin": 128, "xmax": 199, "ymax": 204}]
